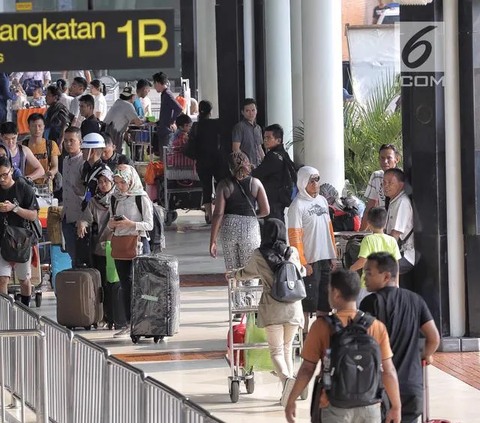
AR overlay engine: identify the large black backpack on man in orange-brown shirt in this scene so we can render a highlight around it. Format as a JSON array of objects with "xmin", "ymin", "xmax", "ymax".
[{"xmin": 322, "ymin": 311, "xmax": 383, "ymax": 408}]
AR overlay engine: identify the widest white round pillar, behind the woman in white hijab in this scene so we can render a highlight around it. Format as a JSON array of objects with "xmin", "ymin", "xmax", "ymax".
[{"xmin": 302, "ymin": 0, "xmax": 345, "ymax": 192}]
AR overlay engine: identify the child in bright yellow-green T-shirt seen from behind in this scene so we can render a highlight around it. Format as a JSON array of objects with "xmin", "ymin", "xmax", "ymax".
[{"xmin": 350, "ymin": 207, "xmax": 402, "ymax": 304}]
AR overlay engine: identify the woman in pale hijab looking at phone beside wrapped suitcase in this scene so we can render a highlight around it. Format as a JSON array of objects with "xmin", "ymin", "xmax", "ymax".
[{"xmin": 108, "ymin": 165, "xmax": 153, "ymax": 338}]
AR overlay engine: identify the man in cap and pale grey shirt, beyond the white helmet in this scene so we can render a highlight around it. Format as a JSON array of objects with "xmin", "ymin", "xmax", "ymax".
[{"xmin": 104, "ymin": 87, "xmax": 143, "ymax": 153}]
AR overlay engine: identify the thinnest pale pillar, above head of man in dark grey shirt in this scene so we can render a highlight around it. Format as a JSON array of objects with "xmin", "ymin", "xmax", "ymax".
[{"xmin": 243, "ymin": 0, "xmax": 255, "ymax": 98}]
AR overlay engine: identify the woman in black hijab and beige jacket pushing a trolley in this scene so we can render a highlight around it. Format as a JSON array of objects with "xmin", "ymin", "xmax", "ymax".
[{"xmin": 232, "ymin": 219, "xmax": 305, "ymax": 406}]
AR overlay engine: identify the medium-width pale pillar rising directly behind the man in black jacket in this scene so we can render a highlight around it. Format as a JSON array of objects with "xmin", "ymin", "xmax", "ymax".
[{"xmin": 265, "ymin": 0, "xmax": 293, "ymax": 155}]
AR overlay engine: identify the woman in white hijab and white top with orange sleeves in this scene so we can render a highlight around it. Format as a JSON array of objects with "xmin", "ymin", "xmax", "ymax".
[{"xmin": 288, "ymin": 166, "xmax": 337, "ymax": 337}]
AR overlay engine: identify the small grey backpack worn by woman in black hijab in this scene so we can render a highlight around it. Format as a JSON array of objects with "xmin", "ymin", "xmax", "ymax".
[{"xmin": 270, "ymin": 260, "xmax": 307, "ymax": 303}]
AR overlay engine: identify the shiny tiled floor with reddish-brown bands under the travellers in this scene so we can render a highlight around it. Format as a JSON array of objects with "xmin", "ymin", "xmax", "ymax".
[{"xmin": 31, "ymin": 217, "xmax": 480, "ymax": 423}]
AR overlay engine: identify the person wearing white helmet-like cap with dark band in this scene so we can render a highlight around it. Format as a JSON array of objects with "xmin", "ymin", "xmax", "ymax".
[{"xmin": 82, "ymin": 132, "xmax": 110, "ymax": 212}]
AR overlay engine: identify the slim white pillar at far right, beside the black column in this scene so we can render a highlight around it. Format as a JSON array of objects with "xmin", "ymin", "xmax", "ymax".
[{"xmin": 443, "ymin": 0, "xmax": 465, "ymax": 336}]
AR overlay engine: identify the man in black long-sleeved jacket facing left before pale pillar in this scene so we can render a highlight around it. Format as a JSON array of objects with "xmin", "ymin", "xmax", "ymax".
[{"xmin": 252, "ymin": 124, "xmax": 296, "ymax": 223}]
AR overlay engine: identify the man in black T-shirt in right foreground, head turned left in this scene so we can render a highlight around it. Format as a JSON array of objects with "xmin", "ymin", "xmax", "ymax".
[{"xmin": 360, "ymin": 253, "xmax": 440, "ymax": 423}]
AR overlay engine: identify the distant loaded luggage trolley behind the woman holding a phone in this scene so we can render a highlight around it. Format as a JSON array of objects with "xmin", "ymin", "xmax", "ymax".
[{"xmin": 159, "ymin": 147, "xmax": 203, "ymax": 226}]
